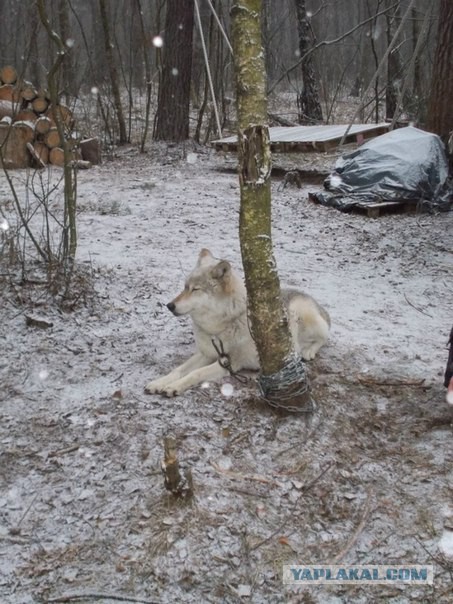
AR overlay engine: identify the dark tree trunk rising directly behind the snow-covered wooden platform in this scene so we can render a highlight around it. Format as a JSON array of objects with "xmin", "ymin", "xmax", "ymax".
[{"xmin": 294, "ymin": 0, "xmax": 322, "ymax": 124}]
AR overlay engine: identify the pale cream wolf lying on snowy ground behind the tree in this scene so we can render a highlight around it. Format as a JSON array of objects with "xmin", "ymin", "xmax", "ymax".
[{"xmin": 145, "ymin": 249, "xmax": 330, "ymax": 396}]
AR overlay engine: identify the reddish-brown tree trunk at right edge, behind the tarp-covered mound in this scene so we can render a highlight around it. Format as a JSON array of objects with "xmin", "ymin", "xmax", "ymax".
[{"xmin": 426, "ymin": 0, "xmax": 453, "ymax": 174}]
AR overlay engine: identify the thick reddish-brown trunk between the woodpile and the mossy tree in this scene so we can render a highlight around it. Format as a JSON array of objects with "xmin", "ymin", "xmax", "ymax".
[{"xmin": 154, "ymin": 0, "xmax": 194, "ymax": 142}]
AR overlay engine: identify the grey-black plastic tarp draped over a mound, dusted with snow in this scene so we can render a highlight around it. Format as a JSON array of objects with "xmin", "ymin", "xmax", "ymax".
[{"xmin": 310, "ymin": 127, "xmax": 453, "ymax": 211}]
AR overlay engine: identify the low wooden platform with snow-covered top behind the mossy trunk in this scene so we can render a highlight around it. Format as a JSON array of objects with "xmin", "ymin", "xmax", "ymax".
[{"xmin": 211, "ymin": 123, "xmax": 390, "ymax": 153}]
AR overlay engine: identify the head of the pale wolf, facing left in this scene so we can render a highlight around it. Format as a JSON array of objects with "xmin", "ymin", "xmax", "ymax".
[{"xmin": 167, "ymin": 249, "xmax": 235, "ymax": 318}]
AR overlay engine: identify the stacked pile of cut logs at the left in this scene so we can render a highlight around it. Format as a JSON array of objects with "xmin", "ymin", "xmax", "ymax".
[{"xmin": 0, "ymin": 65, "xmax": 101, "ymax": 168}]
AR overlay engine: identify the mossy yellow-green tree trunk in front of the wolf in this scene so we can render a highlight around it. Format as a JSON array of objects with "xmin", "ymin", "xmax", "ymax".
[{"xmin": 231, "ymin": 0, "xmax": 309, "ymax": 407}]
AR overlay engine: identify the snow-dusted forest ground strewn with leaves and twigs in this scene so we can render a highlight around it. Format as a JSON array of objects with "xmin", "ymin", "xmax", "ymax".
[{"xmin": 0, "ymin": 144, "xmax": 453, "ymax": 604}]
